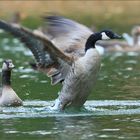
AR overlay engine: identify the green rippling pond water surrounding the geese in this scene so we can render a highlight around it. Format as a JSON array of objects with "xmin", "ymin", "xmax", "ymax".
[{"xmin": 0, "ymin": 35, "xmax": 140, "ymax": 140}]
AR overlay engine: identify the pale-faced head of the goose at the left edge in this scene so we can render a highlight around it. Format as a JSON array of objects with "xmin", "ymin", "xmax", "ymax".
[{"xmin": 2, "ymin": 59, "xmax": 15, "ymax": 71}]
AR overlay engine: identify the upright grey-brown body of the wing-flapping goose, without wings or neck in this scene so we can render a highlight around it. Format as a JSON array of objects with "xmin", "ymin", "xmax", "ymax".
[{"xmin": 52, "ymin": 48, "xmax": 100, "ymax": 109}]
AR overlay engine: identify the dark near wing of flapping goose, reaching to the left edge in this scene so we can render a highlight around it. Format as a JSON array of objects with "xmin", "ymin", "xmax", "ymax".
[{"xmin": 0, "ymin": 20, "xmax": 73, "ymax": 84}]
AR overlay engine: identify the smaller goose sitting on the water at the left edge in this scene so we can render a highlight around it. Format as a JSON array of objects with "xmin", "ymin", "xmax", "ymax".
[{"xmin": 0, "ymin": 59, "xmax": 22, "ymax": 106}]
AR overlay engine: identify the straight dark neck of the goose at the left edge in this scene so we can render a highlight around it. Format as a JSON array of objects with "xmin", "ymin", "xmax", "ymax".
[{"xmin": 2, "ymin": 70, "xmax": 11, "ymax": 86}]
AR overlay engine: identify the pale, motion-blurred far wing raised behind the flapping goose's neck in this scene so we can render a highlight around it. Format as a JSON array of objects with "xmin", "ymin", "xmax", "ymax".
[{"xmin": 41, "ymin": 16, "xmax": 93, "ymax": 57}]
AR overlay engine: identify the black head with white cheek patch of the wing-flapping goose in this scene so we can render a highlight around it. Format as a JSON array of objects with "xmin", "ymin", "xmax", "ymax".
[{"xmin": 100, "ymin": 30, "xmax": 122, "ymax": 40}]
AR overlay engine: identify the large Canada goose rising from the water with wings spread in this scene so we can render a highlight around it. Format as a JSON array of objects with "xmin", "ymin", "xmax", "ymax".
[{"xmin": 0, "ymin": 16, "xmax": 121, "ymax": 109}]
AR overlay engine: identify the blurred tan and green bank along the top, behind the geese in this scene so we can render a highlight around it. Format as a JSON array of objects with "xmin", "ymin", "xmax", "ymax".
[{"xmin": 0, "ymin": 0, "xmax": 140, "ymax": 33}]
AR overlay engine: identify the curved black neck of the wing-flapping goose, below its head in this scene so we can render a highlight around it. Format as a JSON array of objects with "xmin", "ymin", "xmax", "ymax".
[{"xmin": 85, "ymin": 33, "xmax": 101, "ymax": 52}]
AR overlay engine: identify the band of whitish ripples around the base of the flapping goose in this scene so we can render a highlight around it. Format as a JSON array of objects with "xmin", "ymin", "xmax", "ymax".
[{"xmin": 0, "ymin": 100, "xmax": 140, "ymax": 118}]
